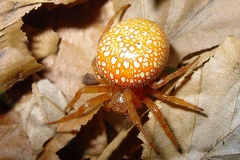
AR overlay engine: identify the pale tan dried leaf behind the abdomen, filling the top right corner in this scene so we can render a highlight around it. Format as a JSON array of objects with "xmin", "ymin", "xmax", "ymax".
[{"xmin": 114, "ymin": 0, "xmax": 240, "ymax": 67}]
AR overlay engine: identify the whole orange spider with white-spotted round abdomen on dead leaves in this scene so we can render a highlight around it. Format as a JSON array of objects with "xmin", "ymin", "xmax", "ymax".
[{"xmin": 50, "ymin": 5, "xmax": 203, "ymax": 153}]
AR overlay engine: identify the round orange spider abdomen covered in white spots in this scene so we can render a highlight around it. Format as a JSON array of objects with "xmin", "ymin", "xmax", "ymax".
[{"xmin": 96, "ymin": 18, "xmax": 169, "ymax": 88}]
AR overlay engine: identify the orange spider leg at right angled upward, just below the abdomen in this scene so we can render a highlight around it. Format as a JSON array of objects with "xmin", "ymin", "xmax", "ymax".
[{"xmin": 149, "ymin": 57, "xmax": 199, "ymax": 89}]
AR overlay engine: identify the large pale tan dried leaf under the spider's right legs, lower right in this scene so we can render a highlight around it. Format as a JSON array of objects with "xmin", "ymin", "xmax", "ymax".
[{"xmin": 140, "ymin": 37, "xmax": 240, "ymax": 159}]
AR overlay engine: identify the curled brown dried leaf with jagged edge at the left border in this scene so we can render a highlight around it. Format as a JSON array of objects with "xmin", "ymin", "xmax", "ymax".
[{"xmin": 0, "ymin": 21, "xmax": 44, "ymax": 91}]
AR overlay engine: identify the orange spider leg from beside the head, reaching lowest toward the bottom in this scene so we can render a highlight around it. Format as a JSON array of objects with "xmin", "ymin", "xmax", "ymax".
[{"xmin": 123, "ymin": 89, "xmax": 159, "ymax": 154}]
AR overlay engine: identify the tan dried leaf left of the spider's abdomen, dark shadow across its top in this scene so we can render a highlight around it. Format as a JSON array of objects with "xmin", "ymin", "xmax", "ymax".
[{"xmin": 43, "ymin": 1, "xmax": 113, "ymax": 97}]
